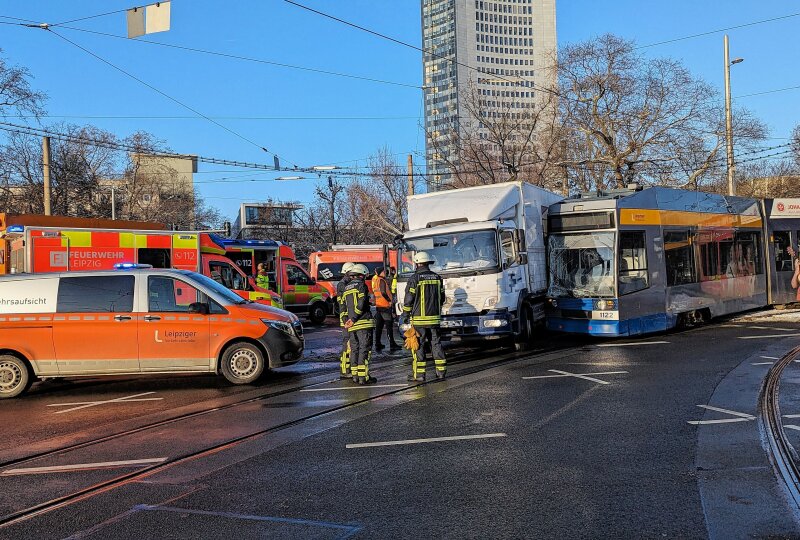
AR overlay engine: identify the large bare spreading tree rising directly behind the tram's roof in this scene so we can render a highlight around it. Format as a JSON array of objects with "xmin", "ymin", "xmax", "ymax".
[{"xmin": 559, "ymin": 35, "xmax": 766, "ymax": 191}]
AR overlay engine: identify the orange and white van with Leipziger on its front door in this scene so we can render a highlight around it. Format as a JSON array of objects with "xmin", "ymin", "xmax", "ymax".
[{"xmin": 0, "ymin": 265, "xmax": 304, "ymax": 398}]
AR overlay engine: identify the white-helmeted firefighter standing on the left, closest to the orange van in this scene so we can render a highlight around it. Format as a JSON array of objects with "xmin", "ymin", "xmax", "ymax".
[{"xmin": 342, "ymin": 264, "xmax": 377, "ymax": 385}]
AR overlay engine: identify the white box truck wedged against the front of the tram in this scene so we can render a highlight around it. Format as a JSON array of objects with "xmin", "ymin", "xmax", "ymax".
[{"xmin": 397, "ymin": 182, "xmax": 563, "ymax": 349}]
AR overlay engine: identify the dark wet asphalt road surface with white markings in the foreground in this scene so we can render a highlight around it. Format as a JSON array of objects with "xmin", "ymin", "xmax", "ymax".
[{"xmin": 0, "ymin": 318, "xmax": 800, "ymax": 539}]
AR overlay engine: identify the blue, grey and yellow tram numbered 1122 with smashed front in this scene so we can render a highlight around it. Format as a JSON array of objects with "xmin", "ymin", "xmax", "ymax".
[{"xmin": 547, "ymin": 188, "xmax": 800, "ymax": 336}]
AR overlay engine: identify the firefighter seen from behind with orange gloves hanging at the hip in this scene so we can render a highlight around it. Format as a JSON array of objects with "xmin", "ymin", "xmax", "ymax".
[{"xmin": 403, "ymin": 251, "xmax": 447, "ymax": 381}]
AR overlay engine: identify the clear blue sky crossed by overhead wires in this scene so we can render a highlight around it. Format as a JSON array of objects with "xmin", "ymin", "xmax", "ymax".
[{"xmin": 0, "ymin": 0, "xmax": 800, "ymax": 217}]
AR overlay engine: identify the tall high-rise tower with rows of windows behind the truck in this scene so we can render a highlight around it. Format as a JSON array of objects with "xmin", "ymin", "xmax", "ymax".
[{"xmin": 422, "ymin": 0, "xmax": 556, "ymax": 190}]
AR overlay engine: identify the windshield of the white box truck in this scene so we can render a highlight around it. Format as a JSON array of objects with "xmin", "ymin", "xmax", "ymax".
[{"xmin": 402, "ymin": 230, "xmax": 500, "ymax": 275}]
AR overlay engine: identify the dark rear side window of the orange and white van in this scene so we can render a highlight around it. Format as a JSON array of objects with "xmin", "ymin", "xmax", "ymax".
[{"xmin": 56, "ymin": 276, "xmax": 134, "ymax": 313}]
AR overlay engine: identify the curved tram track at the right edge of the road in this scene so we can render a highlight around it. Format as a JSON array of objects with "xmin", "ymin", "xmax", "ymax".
[{"xmin": 758, "ymin": 347, "xmax": 800, "ymax": 510}]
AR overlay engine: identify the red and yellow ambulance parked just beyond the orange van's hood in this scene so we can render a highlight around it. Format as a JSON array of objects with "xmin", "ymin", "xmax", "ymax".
[{"xmin": 215, "ymin": 237, "xmax": 333, "ymax": 324}]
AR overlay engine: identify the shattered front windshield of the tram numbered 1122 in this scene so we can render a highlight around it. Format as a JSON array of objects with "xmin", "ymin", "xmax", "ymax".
[{"xmin": 548, "ymin": 232, "xmax": 616, "ymax": 298}]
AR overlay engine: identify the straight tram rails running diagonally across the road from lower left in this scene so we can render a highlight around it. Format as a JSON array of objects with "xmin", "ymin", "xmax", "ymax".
[{"xmin": 0, "ymin": 345, "xmax": 578, "ymax": 528}]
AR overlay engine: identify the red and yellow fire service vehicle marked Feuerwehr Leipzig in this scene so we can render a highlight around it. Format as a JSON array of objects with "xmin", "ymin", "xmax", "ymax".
[{"xmin": 4, "ymin": 225, "xmax": 283, "ymax": 308}]
